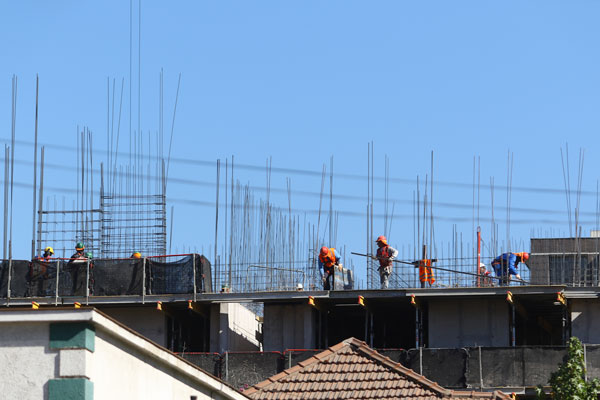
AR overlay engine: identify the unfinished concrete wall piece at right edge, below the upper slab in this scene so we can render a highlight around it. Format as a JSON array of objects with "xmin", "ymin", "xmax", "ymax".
[{"xmin": 569, "ymin": 299, "xmax": 600, "ymax": 344}]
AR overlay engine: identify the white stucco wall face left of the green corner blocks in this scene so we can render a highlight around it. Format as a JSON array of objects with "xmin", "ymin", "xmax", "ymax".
[{"xmin": 0, "ymin": 322, "xmax": 58, "ymax": 400}]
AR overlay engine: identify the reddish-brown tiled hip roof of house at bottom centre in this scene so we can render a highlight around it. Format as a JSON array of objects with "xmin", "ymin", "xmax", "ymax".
[{"xmin": 244, "ymin": 338, "xmax": 510, "ymax": 400}]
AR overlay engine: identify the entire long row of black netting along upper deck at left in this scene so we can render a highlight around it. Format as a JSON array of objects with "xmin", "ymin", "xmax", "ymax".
[{"xmin": 0, "ymin": 254, "xmax": 212, "ymax": 298}]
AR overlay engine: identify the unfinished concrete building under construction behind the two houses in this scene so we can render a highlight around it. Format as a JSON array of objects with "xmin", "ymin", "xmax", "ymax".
[{"xmin": 0, "ymin": 234, "xmax": 600, "ymax": 395}]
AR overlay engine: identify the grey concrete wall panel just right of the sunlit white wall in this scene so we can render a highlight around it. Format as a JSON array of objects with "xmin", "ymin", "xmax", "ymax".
[{"xmin": 263, "ymin": 304, "xmax": 317, "ymax": 351}]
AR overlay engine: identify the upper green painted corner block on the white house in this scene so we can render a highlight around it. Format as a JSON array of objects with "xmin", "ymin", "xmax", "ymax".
[{"xmin": 50, "ymin": 322, "xmax": 96, "ymax": 352}]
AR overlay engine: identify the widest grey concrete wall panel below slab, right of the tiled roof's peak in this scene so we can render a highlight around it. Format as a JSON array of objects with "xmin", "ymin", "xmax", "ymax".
[{"xmin": 428, "ymin": 298, "xmax": 509, "ymax": 347}]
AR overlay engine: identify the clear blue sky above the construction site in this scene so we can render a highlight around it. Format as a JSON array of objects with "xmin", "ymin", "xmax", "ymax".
[{"xmin": 0, "ymin": 0, "xmax": 600, "ymax": 284}]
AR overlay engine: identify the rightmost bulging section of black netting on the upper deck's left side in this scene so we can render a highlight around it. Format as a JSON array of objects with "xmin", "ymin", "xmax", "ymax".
[{"xmin": 146, "ymin": 254, "xmax": 212, "ymax": 294}]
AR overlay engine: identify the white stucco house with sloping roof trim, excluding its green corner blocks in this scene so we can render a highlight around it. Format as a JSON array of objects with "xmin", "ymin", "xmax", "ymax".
[{"xmin": 0, "ymin": 309, "xmax": 248, "ymax": 400}]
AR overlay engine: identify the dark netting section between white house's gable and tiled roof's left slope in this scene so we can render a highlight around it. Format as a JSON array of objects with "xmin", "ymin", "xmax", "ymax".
[{"xmin": 223, "ymin": 351, "xmax": 284, "ymax": 390}]
